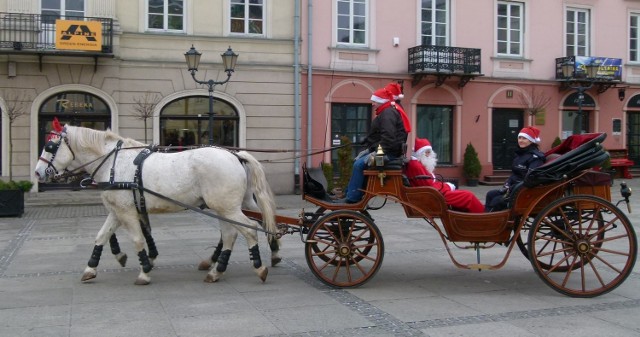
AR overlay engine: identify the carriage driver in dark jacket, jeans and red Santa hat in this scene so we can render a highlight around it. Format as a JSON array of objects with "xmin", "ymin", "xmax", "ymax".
[{"xmin": 336, "ymin": 83, "xmax": 411, "ymax": 204}]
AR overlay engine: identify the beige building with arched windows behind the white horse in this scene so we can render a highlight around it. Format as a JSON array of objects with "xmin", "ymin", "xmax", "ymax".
[{"xmin": 0, "ymin": 0, "xmax": 299, "ymax": 193}]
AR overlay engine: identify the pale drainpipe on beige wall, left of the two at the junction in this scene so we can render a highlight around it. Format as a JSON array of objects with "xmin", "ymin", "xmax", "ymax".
[{"xmin": 293, "ymin": 0, "xmax": 302, "ymax": 194}]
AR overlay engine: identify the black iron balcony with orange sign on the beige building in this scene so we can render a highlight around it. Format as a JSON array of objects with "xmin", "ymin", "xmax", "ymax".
[{"xmin": 0, "ymin": 13, "xmax": 113, "ymax": 69}]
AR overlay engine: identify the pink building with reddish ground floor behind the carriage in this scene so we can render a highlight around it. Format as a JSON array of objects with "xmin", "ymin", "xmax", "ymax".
[{"xmin": 301, "ymin": 0, "xmax": 640, "ymax": 184}]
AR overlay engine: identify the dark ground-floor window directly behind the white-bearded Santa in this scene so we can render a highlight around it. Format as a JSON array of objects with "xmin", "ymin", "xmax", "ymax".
[{"xmin": 416, "ymin": 105, "xmax": 453, "ymax": 164}]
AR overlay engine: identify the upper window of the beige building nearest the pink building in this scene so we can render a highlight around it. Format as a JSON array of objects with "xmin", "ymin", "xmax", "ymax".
[{"xmin": 229, "ymin": 0, "xmax": 264, "ymax": 34}]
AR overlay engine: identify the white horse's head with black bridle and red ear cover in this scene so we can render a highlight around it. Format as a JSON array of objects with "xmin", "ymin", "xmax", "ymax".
[{"xmin": 35, "ymin": 119, "xmax": 76, "ymax": 182}]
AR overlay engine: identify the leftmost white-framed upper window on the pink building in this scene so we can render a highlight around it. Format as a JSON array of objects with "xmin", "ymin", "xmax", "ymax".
[{"xmin": 337, "ymin": 0, "xmax": 367, "ymax": 46}]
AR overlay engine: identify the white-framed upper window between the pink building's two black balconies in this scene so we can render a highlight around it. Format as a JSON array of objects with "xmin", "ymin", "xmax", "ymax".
[{"xmin": 495, "ymin": 1, "xmax": 525, "ymax": 57}]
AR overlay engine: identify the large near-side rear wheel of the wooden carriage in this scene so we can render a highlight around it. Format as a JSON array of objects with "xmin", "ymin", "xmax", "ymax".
[{"xmin": 529, "ymin": 195, "xmax": 637, "ymax": 297}]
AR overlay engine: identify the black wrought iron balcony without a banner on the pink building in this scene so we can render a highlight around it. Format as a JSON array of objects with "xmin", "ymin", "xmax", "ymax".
[{"xmin": 409, "ymin": 45, "xmax": 483, "ymax": 87}]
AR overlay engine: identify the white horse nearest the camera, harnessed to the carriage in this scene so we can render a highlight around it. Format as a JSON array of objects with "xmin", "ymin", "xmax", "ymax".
[{"xmin": 35, "ymin": 122, "xmax": 277, "ymax": 284}]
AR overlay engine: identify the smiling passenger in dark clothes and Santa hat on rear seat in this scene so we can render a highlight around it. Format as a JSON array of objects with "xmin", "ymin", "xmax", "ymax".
[{"xmin": 485, "ymin": 126, "xmax": 545, "ymax": 212}]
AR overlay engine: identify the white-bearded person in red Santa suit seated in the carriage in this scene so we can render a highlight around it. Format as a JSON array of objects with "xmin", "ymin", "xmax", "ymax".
[{"xmin": 405, "ymin": 138, "xmax": 484, "ymax": 213}]
